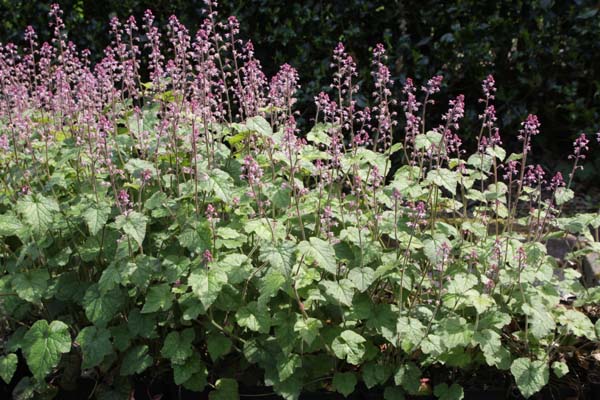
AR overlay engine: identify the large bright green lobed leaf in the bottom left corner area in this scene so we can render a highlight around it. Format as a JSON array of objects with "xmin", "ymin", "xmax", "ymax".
[{"xmin": 22, "ymin": 319, "xmax": 71, "ymax": 380}]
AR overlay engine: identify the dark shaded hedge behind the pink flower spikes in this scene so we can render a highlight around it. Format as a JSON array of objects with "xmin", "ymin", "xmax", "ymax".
[{"xmin": 0, "ymin": 0, "xmax": 600, "ymax": 187}]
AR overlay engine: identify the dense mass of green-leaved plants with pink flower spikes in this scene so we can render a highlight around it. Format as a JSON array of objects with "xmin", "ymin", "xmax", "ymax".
[{"xmin": 0, "ymin": 1, "xmax": 600, "ymax": 400}]
